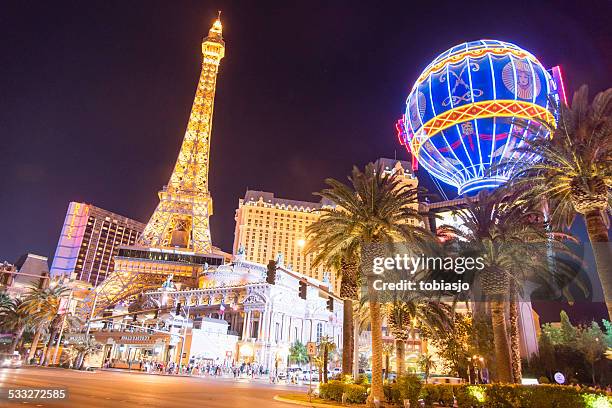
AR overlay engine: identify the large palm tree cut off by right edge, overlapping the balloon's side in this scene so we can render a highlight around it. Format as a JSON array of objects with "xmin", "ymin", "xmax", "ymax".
[{"xmin": 511, "ymin": 85, "xmax": 612, "ymax": 317}]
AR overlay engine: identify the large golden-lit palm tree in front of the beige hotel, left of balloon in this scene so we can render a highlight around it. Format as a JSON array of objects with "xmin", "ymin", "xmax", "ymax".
[{"xmin": 307, "ymin": 163, "xmax": 430, "ymax": 404}]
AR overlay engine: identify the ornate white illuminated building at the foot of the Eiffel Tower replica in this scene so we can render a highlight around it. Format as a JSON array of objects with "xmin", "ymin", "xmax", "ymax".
[{"xmin": 87, "ymin": 254, "xmax": 343, "ymax": 371}]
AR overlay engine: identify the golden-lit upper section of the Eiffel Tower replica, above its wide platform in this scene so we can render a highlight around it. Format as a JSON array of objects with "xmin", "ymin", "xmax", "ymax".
[{"xmin": 139, "ymin": 12, "xmax": 225, "ymax": 253}]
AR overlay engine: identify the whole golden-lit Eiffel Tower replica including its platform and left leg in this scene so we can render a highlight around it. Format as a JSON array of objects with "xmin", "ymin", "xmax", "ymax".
[{"xmin": 80, "ymin": 13, "xmax": 227, "ymax": 317}]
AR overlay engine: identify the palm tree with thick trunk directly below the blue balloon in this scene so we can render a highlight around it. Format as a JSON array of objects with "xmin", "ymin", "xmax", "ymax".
[{"xmin": 439, "ymin": 190, "xmax": 576, "ymax": 382}]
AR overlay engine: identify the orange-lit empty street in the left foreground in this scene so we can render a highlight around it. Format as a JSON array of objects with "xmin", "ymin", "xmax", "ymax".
[{"xmin": 0, "ymin": 368, "xmax": 305, "ymax": 408}]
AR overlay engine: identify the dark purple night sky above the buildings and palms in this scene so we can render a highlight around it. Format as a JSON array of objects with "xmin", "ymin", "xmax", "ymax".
[{"xmin": 0, "ymin": 0, "xmax": 612, "ymax": 322}]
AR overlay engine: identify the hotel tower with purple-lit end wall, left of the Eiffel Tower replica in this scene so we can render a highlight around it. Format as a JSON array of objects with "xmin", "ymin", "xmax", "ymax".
[{"xmin": 51, "ymin": 202, "xmax": 145, "ymax": 286}]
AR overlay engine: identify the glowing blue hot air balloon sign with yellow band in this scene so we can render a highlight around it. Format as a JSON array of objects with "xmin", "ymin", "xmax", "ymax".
[{"xmin": 398, "ymin": 40, "xmax": 564, "ymax": 194}]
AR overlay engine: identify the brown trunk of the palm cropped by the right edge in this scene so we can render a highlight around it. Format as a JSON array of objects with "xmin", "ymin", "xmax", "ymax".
[{"xmin": 584, "ymin": 210, "xmax": 612, "ymax": 319}]
